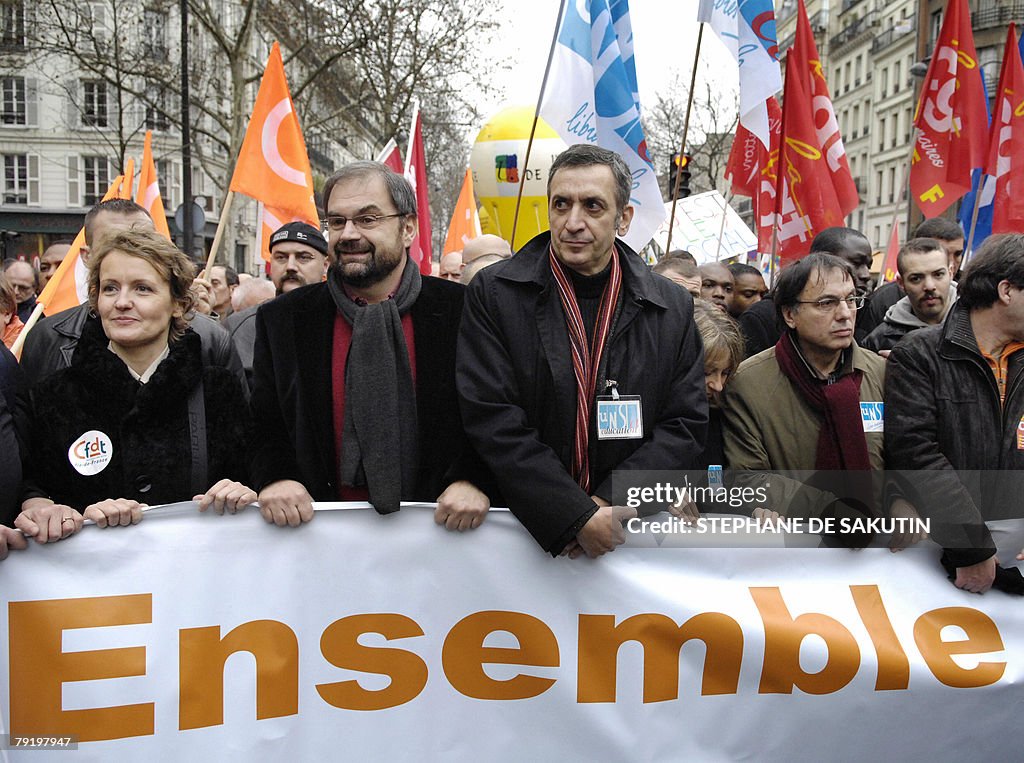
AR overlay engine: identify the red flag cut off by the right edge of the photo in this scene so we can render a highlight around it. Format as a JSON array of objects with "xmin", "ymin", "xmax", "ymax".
[{"xmin": 985, "ymin": 24, "xmax": 1024, "ymax": 234}]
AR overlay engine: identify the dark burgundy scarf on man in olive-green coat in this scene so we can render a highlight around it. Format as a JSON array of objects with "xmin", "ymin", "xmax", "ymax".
[{"xmin": 775, "ymin": 332, "xmax": 871, "ymax": 471}]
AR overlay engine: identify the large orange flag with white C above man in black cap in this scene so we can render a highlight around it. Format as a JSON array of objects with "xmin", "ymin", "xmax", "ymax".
[{"xmin": 230, "ymin": 42, "xmax": 319, "ymax": 225}]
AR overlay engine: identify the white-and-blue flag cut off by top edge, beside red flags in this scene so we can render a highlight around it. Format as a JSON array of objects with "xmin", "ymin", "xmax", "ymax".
[{"xmin": 697, "ymin": 0, "xmax": 782, "ymax": 150}]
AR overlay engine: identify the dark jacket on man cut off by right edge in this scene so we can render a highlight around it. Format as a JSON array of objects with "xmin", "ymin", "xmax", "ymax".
[{"xmin": 885, "ymin": 304, "xmax": 1024, "ymax": 567}]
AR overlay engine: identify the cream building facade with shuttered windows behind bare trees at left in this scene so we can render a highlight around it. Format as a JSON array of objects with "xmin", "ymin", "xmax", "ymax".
[{"xmin": 0, "ymin": 0, "xmax": 375, "ymax": 272}]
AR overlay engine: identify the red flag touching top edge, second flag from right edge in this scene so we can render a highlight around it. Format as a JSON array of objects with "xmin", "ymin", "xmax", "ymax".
[{"xmin": 910, "ymin": 0, "xmax": 988, "ymax": 217}]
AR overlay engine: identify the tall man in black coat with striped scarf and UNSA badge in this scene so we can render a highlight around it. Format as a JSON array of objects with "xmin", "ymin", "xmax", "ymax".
[{"xmin": 457, "ymin": 144, "xmax": 708, "ymax": 557}]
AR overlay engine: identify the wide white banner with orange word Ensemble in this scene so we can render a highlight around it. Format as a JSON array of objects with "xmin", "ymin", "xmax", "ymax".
[{"xmin": 0, "ymin": 508, "xmax": 1024, "ymax": 763}]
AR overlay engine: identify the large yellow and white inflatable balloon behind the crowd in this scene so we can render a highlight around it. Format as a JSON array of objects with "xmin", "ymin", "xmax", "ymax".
[{"xmin": 470, "ymin": 107, "xmax": 566, "ymax": 251}]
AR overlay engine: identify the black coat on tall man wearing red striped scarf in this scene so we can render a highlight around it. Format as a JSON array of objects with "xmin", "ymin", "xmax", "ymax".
[{"xmin": 457, "ymin": 234, "xmax": 708, "ymax": 554}]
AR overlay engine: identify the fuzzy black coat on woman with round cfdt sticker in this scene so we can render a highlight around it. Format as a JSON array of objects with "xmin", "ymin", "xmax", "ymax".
[{"xmin": 18, "ymin": 317, "xmax": 250, "ymax": 510}]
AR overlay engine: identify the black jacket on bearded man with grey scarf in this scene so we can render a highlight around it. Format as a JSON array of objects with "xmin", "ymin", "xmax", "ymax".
[{"xmin": 252, "ymin": 272, "xmax": 487, "ymax": 501}]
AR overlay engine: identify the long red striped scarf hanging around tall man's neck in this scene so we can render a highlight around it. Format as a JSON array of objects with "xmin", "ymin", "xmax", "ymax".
[{"xmin": 548, "ymin": 248, "xmax": 623, "ymax": 495}]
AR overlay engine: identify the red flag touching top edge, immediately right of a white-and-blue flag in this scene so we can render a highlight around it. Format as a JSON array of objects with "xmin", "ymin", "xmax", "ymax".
[{"xmin": 786, "ymin": 0, "xmax": 860, "ymax": 217}]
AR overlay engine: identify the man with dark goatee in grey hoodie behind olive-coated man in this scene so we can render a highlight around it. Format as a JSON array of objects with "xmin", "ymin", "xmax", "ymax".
[{"xmin": 860, "ymin": 239, "xmax": 956, "ymax": 356}]
